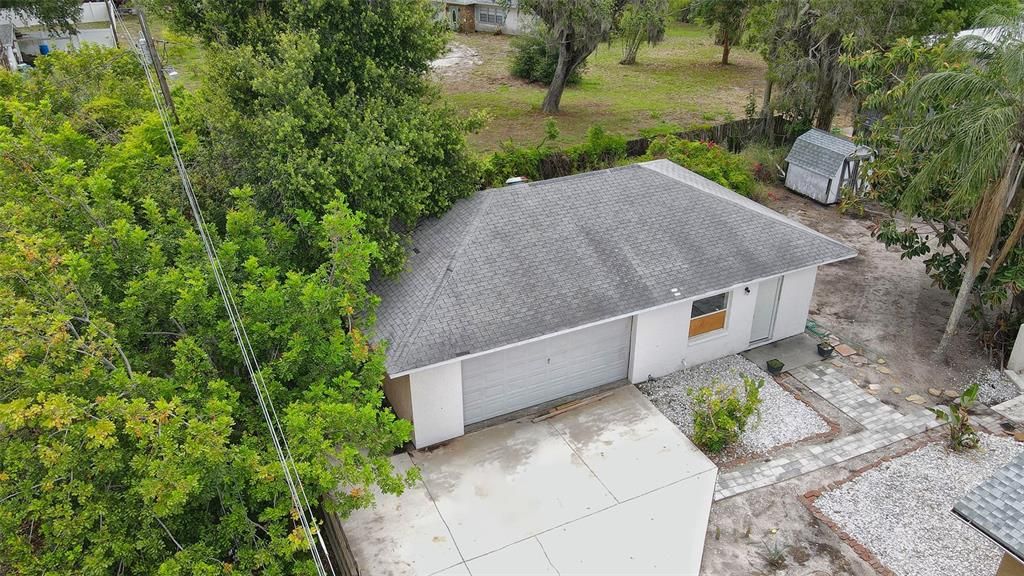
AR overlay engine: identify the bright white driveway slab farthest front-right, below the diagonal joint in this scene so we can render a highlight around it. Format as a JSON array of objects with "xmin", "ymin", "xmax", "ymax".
[{"xmin": 538, "ymin": 470, "xmax": 717, "ymax": 574}]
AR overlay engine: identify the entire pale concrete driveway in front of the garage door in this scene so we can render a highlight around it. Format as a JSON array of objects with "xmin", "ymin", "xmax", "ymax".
[{"xmin": 344, "ymin": 385, "xmax": 717, "ymax": 576}]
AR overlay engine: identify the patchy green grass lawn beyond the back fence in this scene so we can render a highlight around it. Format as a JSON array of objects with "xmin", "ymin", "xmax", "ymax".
[{"xmin": 439, "ymin": 23, "xmax": 765, "ymax": 152}]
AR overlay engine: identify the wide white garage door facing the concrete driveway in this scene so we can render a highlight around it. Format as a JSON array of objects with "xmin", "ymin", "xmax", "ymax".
[{"xmin": 462, "ymin": 318, "xmax": 632, "ymax": 424}]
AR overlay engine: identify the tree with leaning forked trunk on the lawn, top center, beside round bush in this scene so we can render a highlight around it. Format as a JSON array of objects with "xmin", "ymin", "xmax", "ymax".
[{"xmin": 519, "ymin": 0, "xmax": 613, "ymax": 114}]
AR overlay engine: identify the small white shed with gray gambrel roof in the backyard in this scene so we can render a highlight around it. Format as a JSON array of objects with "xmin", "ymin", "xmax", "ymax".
[{"xmin": 785, "ymin": 128, "xmax": 871, "ymax": 204}]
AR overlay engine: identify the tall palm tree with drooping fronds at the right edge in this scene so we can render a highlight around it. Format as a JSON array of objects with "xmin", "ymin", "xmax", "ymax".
[{"xmin": 903, "ymin": 12, "xmax": 1024, "ymax": 354}]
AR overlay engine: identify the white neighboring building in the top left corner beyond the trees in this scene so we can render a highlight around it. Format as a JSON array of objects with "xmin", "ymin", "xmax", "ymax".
[{"xmin": 0, "ymin": 2, "xmax": 117, "ymax": 70}]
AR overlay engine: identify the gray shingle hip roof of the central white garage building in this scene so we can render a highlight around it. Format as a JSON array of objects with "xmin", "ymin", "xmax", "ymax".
[{"xmin": 371, "ymin": 160, "xmax": 856, "ymax": 375}]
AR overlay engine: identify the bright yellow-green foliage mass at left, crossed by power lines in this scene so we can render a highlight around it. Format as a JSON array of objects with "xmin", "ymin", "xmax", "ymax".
[{"xmin": 0, "ymin": 47, "xmax": 416, "ymax": 575}]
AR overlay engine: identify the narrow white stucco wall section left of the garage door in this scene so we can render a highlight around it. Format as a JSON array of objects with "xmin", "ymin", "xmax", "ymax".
[{"xmin": 405, "ymin": 362, "xmax": 465, "ymax": 448}]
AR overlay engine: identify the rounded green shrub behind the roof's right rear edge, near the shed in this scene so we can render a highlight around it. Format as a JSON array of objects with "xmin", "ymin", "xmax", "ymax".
[{"xmin": 644, "ymin": 136, "xmax": 758, "ymax": 198}]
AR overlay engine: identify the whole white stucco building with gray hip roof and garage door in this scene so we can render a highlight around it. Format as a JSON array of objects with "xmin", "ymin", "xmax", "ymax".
[{"xmin": 372, "ymin": 160, "xmax": 856, "ymax": 448}]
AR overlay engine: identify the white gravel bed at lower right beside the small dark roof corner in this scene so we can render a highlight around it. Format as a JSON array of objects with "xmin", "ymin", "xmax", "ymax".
[{"xmin": 815, "ymin": 434, "xmax": 1022, "ymax": 576}]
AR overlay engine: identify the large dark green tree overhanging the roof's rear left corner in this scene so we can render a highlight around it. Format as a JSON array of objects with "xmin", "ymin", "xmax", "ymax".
[{"xmin": 149, "ymin": 0, "xmax": 479, "ymax": 273}]
